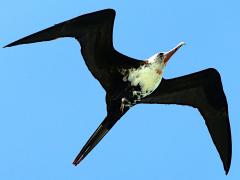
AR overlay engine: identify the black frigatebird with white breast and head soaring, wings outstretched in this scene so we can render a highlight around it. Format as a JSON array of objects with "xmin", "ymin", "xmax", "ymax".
[{"xmin": 5, "ymin": 9, "xmax": 232, "ymax": 174}]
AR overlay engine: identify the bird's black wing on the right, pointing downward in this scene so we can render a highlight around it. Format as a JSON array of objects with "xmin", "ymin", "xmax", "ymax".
[{"xmin": 142, "ymin": 69, "xmax": 232, "ymax": 174}]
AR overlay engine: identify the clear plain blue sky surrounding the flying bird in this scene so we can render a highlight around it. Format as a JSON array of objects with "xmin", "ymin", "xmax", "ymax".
[{"xmin": 0, "ymin": 0, "xmax": 240, "ymax": 180}]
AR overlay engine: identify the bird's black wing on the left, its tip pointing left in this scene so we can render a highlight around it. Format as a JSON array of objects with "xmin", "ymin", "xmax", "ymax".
[{"xmin": 5, "ymin": 9, "xmax": 116, "ymax": 89}]
